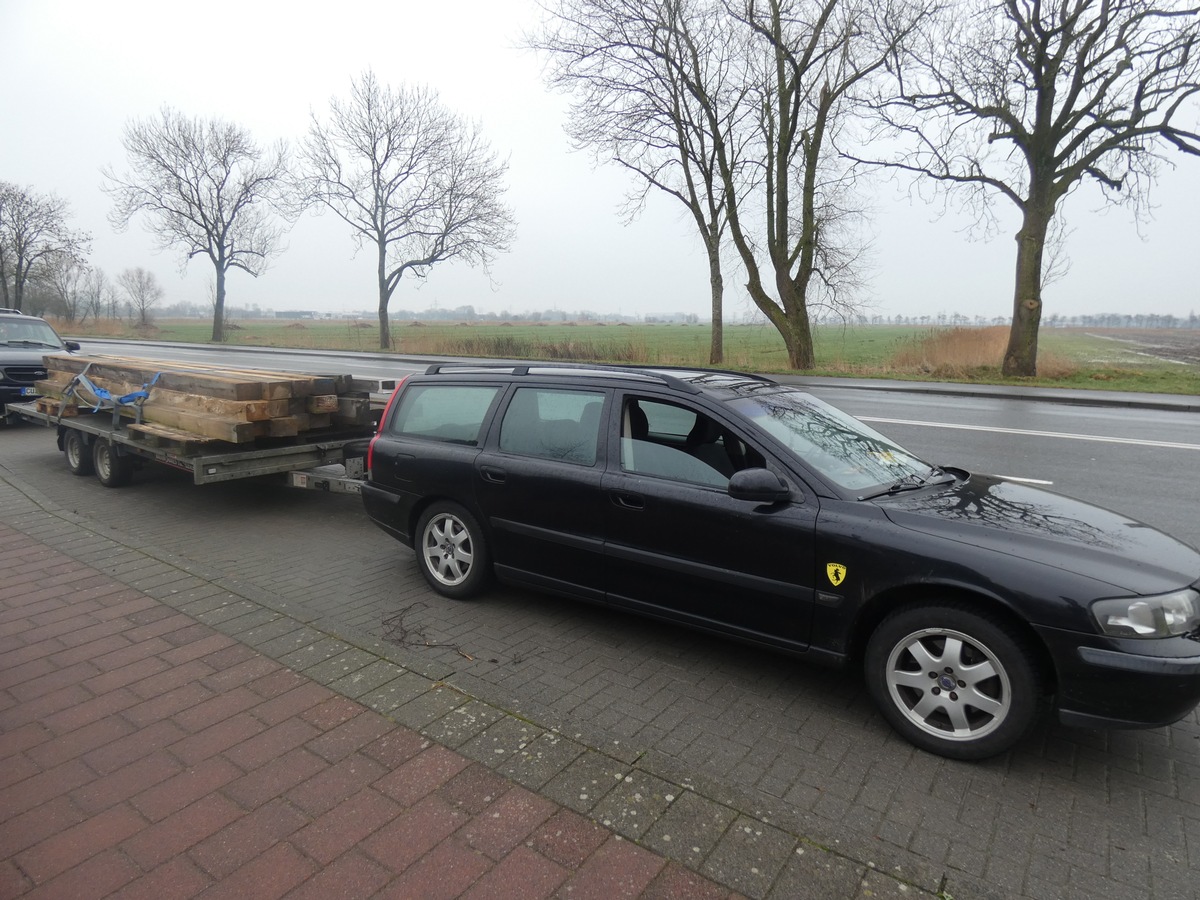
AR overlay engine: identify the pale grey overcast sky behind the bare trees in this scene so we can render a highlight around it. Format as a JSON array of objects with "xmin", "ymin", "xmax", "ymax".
[{"xmin": 0, "ymin": 0, "xmax": 1200, "ymax": 319}]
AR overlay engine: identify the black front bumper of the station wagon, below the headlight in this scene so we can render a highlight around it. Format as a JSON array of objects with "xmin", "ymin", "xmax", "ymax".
[{"xmin": 1038, "ymin": 628, "xmax": 1200, "ymax": 728}]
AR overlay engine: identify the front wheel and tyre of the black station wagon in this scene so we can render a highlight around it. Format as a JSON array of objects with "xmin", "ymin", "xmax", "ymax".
[{"xmin": 864, "ymin": 604, "xmax": 1042, "ymax": 760}]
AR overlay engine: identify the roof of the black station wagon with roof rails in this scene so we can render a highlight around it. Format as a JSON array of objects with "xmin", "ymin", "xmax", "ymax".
[{"xmin": 425, "ymin": 362, "xmax": 782, "ymax": 396}]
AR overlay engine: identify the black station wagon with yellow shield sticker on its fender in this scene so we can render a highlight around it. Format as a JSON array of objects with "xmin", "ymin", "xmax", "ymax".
[{"xmin": 362, "ymin": 364, "xmax": 1200, "ymax": 760}]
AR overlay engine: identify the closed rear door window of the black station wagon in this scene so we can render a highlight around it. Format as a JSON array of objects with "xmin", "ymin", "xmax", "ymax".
[{"xmin": 500, "ymin": 388, "xmax": 604, "ymax": 466}]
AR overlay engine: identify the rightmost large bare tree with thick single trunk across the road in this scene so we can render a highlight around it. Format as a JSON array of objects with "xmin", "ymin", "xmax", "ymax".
[{"xmin": 864, "ymin": 0, "xmax": 1200, "ymax": 376}]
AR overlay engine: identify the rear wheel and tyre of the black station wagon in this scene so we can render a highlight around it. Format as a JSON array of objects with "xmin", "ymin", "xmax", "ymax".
[{"xmin": 415, "ymin": 502, "xmax": 491, "ymax": 600}]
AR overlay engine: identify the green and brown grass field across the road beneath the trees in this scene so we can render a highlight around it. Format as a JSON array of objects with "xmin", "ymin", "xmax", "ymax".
[{"xmin": 56, "ymin": 319, "xmax": 1200, "ymax": 394}]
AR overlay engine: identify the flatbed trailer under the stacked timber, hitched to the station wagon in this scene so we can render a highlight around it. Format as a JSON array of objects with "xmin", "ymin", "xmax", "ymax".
[{"xmin": 8, "ymin": 402, "xmax": 373, "ymax": 493}]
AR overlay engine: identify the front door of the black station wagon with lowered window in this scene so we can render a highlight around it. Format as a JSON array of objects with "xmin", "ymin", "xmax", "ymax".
[{"xmin": 604, "ymin": 392, "xmax": 818, "ymax": 648}]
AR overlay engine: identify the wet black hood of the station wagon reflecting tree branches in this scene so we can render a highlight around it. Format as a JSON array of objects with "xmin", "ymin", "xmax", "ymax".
[{"xmin": 878, "ymin": 475, "xmax": 1200, "ymax": 594}]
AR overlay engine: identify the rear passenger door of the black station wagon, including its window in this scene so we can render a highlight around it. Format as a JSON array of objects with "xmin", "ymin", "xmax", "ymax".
[{"xmin": 474, "ymin": 385, "xmax": 611, "ymax": 600}]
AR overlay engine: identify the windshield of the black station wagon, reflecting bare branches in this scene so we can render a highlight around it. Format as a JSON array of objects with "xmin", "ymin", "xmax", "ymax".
[{"xmin": 731, "ymin": 389, "xmax": 934, "ymax": 491}]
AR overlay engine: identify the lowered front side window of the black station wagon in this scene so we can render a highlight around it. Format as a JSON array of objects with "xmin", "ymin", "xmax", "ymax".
[{"xmin": 620, "ymin": 397, "xmax": 764, "ymax": 487}]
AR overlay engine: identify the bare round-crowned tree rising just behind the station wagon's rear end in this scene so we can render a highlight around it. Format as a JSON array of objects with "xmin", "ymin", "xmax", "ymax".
[{"xmin": 296, "ymin": 71, "xmax": 515, "ymax": 349}]
